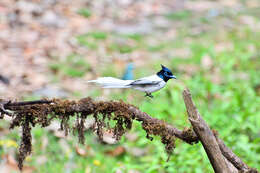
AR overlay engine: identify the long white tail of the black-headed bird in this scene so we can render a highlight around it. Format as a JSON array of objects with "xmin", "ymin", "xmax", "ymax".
[{"xmin": 88, "ymin": 77, "xmax": 133, "ymax": 88}]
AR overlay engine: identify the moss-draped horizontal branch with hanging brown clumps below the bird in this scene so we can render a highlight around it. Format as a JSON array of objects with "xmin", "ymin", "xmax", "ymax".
[{"xmin": 0, "ymin": 90, "xmax": 256, "ymax": 172}]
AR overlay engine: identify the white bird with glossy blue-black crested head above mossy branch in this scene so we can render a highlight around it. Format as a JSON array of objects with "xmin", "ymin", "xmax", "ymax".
[{"xmin": 88, "ymin": 65, "xmax": 177, "ymax": 98}]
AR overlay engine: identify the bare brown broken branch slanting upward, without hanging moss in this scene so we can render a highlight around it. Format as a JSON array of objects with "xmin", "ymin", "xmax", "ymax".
[{"xmin": 183, "ymin": 89, "xmax": 258, "ymax": 173}]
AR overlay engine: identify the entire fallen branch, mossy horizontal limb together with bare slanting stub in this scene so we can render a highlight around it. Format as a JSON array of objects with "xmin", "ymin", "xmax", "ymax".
[{"xmin": 0, "ymin": 90, "xmax": 257, "ymax": 173}]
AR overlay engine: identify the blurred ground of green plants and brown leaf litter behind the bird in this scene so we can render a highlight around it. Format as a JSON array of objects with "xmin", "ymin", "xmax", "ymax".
[{"xmin": 0, "ymin": 0, "xmax": 260, "ymax": 173}]
